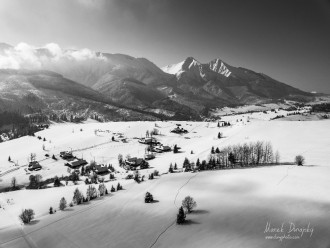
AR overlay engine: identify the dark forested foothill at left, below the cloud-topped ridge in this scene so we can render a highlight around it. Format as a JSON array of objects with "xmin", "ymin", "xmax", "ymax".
[{"xmin": 0, "ymin": 69, "xmax": 165, "ymax": 120}]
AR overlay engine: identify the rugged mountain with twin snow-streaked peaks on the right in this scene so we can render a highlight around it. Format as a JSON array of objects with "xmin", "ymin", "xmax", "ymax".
[{"xmin": 163, "ymin": 57, "xmax": 312, "ymax": 111}]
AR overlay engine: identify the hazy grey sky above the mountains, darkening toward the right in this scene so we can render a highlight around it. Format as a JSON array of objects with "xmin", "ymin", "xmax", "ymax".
[{"xmin": 0, "ymin": 0, "xmax": 330, "ymax": 93}]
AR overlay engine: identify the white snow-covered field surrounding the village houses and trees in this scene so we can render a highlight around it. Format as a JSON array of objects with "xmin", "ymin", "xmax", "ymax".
[{"xmin": 0, "ymin": 116, "xmax": 330, "ymax": 248}]
